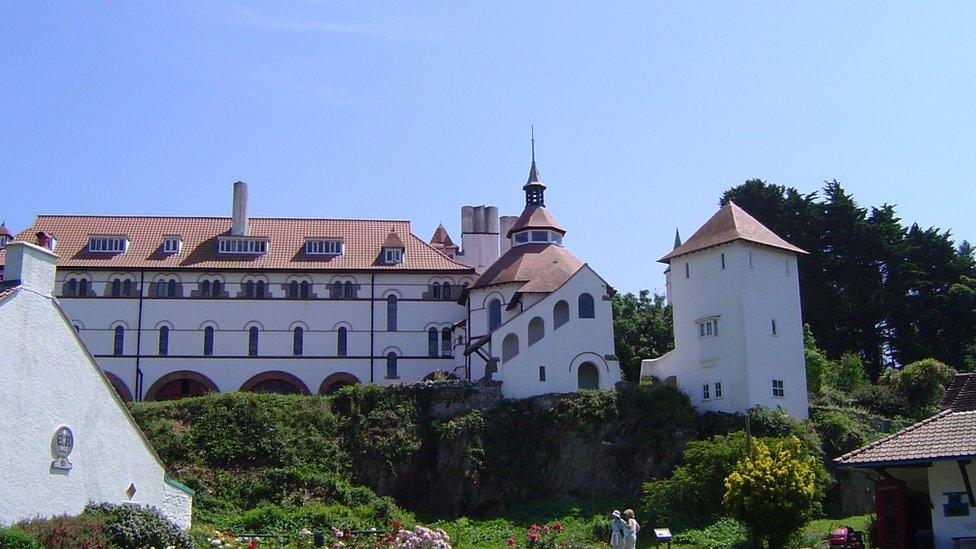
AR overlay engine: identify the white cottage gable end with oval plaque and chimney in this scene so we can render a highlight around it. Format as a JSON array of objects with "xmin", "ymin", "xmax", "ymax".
[{"xmin": 0, "ymin": 242, "xmax": 192, "ymax": 529}]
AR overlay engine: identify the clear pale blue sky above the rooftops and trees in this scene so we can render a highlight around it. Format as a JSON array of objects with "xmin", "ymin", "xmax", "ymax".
[{"xmin": 0, "ymin": 0, "xmax": 976, "ymax": 291}]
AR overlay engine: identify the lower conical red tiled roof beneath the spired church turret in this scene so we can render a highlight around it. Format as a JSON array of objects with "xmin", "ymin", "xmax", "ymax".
[{"xmin": 472, "ymin": 244, "xmax": 583, "ymax": 293}]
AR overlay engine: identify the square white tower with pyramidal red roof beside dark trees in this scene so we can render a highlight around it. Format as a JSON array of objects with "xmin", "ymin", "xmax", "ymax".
[{"xmin": 641, "ymin": 202, "xmax": 808, "ymax": 419}]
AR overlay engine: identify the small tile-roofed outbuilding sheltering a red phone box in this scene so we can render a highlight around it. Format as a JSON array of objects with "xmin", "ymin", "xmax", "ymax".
[{"xmin": 834, "ymin": 373, "xmax": 976, "ymax": 549}]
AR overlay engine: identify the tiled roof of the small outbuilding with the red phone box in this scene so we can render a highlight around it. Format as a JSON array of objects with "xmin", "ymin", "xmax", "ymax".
[{"xmin": 834, "ymin": 409, "xmax": 976, "ymax": 467}]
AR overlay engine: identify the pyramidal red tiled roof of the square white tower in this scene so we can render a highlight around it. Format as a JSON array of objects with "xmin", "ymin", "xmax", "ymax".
[{"xmin": 658, "ymin": 202, "xmax": 807, "ymax": 263}]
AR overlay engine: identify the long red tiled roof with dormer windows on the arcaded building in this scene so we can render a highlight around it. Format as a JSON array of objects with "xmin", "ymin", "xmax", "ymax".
[{"xmin": 0, "ymin": 215, "xmax": 472, "ymax": 272}]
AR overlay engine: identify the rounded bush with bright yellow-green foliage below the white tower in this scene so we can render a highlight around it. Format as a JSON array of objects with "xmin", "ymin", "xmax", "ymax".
[{"xmin": 722, "ymin": 437, "xmax": 819, "ymax": 549}]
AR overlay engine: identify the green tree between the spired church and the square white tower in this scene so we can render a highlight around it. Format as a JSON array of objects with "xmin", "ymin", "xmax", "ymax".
[{"xmin": 611, "ymin": 290, "xmax": 674, "ymax": 383}]
